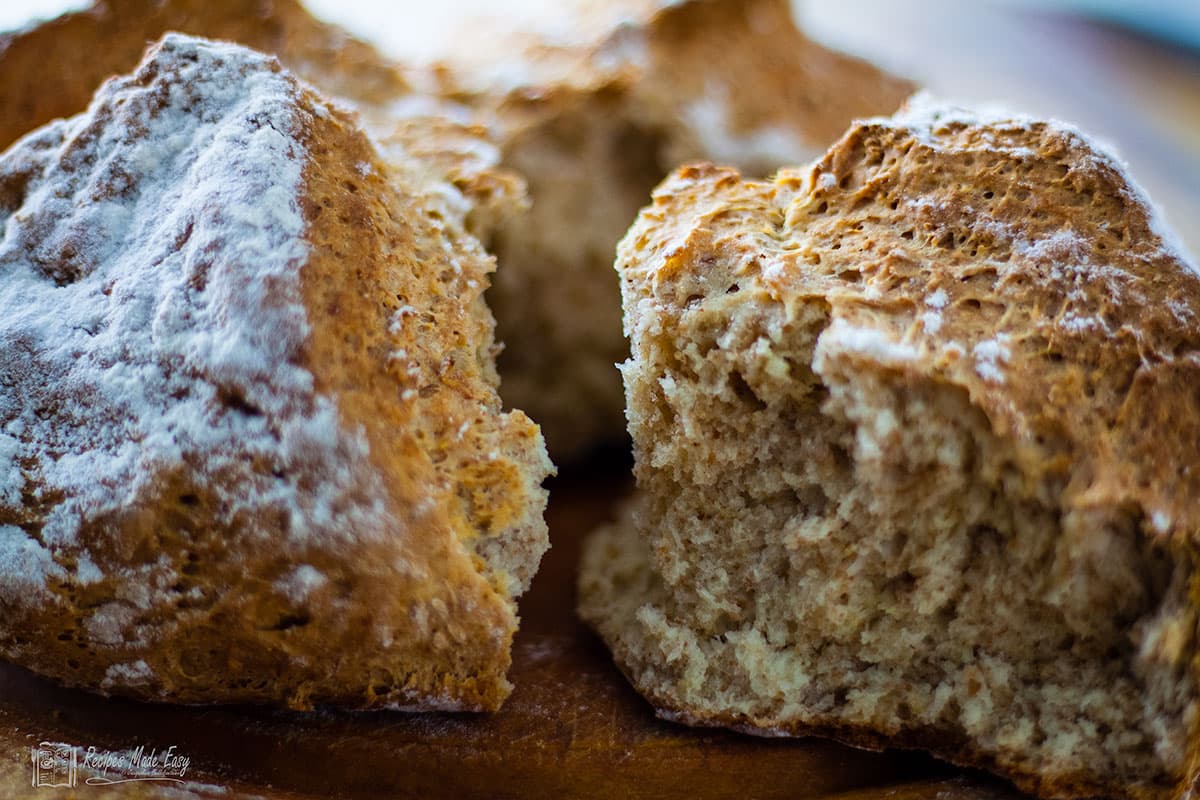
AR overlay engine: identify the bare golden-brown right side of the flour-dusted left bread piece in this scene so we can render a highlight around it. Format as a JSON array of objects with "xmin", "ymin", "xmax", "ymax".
[{"xmin": 285, "ymin": 84, "xmax": 548, "ymax": 710}]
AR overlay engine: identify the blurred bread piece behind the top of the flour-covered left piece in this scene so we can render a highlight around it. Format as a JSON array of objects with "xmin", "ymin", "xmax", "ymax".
[{"xmin": 0, "ymin": 0, "xmax": 523, "ymax": 237}]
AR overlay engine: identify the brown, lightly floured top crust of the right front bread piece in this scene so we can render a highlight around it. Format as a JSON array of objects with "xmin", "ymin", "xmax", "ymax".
[{"xmin": 619, "ymin": 94, "xmax": 1200, "ymax": 540}]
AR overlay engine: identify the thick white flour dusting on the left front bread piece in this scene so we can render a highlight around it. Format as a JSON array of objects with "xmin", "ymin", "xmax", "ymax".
[{"xmin": 0, "ymin": 29, "xmax": 384, "ymax": 606}]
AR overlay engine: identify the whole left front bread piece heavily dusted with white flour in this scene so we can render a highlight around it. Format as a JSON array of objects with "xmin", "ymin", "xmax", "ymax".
[{"xmin": 0, "ymin": 35, "xmax": 552, "ymax": 710}]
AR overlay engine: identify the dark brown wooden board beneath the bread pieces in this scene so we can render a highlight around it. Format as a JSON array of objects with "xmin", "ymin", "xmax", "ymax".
[{"xmin": 0, "ymin": 458, "xmax": 1019, "ymax": 800}]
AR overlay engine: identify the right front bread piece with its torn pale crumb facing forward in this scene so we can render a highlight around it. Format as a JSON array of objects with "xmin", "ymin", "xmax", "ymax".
[{"xmin": 580, "ymin": 103, "xmax": 1200, "ymax": 799}]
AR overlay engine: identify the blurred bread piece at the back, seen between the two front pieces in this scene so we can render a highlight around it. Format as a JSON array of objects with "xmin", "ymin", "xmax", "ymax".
[{"xmin": 442, "ymin": 0, "xmax": 912, "ymax": 457}]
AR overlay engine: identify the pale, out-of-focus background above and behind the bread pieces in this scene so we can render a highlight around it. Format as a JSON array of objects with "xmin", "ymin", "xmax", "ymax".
[{"xmin": 0, "ymin": 0, "xmax": 1200, "ymax": 254}]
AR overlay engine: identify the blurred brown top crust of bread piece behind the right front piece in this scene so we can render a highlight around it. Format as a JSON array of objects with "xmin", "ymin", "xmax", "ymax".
[{"xmin": 633, "ymin": 0, "xmax": 914, "ymax": 175}]
